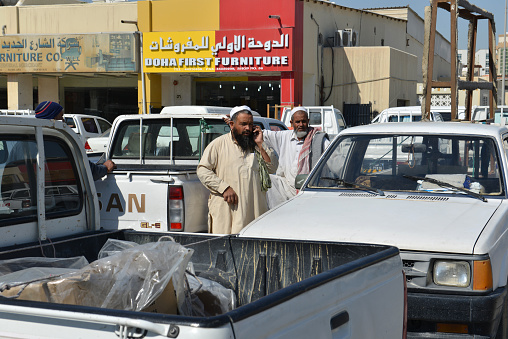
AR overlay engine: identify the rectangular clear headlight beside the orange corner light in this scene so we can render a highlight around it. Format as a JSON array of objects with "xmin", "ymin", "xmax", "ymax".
[{"xmin": 433, "ymin": 261, "xmax": 471, "ymax": 287}]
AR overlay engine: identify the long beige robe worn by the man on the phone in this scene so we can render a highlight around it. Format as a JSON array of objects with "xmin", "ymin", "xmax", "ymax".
[{"xmin": 197, "ymin": 133, "xmax": 278, "ymax": 234}]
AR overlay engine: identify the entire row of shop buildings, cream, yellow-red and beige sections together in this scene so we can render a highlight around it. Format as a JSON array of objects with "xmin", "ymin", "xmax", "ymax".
[{"xmin": 0, "ymin": 0, "xmax": 449, "ymax": 121}]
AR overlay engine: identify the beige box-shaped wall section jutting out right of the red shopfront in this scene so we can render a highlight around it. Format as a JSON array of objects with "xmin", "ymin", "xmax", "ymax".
[{"xmin": 323, "ymin": 47, "xmax": 417, "ymax": 112}]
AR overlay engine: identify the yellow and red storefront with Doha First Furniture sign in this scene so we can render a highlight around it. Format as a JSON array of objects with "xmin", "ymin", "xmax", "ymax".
[{"xmin": 138, "ymin": 0, "xmax": 303, "ymax": 115}]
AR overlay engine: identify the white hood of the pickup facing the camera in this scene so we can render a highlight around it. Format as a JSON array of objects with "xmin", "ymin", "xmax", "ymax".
[{"xmin": 240, "ymin": 191, "xmax": 502, "ymax": 253}]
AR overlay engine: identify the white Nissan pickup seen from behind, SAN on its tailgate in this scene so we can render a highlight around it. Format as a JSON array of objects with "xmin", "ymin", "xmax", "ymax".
[{"xmin": 96, "ymin": 106, "xmax": 285, "ymax": 232}]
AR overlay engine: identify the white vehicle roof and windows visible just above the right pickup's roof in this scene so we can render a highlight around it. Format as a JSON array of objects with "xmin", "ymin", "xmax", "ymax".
[{"xmin": 371, "ymin": 106, "xmax": 465, "ymax": 123}]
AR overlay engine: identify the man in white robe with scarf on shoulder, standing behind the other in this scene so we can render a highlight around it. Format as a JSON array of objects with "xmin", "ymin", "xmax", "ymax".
[{"xmin": 263, "ymin": 107, "xmax": 330, "ymax": 208}]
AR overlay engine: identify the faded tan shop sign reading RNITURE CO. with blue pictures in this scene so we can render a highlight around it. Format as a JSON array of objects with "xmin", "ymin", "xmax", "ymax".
[{"xmin": 0, "ymin": 33, "xmax": 138, "ymax": 73}]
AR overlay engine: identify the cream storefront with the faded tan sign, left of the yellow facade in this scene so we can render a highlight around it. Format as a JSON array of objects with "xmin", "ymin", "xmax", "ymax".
[{"xmin": 0, "ymin": 2, "xmax": 140, "ymax": 121}]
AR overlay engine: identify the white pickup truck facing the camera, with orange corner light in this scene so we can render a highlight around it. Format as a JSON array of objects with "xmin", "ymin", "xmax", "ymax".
[{"xmin": 241, "ymin": 122, "xmax": 508, "ymax": 338}]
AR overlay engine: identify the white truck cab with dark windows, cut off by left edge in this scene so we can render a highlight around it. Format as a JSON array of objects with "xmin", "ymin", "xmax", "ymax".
[{"xmin": 0, "ymin": 116, "xmax": 99, "ymax": 246}]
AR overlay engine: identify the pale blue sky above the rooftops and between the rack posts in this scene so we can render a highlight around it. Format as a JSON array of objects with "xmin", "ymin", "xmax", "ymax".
[{"xmin": 332, "ymin": 0, "xmax": 508, "ymax": 50}]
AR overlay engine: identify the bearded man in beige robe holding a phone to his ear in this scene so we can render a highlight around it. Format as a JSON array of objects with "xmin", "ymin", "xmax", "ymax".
[{"xmin": 197, "ymin": 106, "xmax": 278, "ymax": 234}]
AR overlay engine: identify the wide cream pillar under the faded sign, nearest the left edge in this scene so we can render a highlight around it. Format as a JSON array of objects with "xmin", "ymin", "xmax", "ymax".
[{"xmin": 7, "ymin": 74, "xmax": 34, "ymax": 109}]
